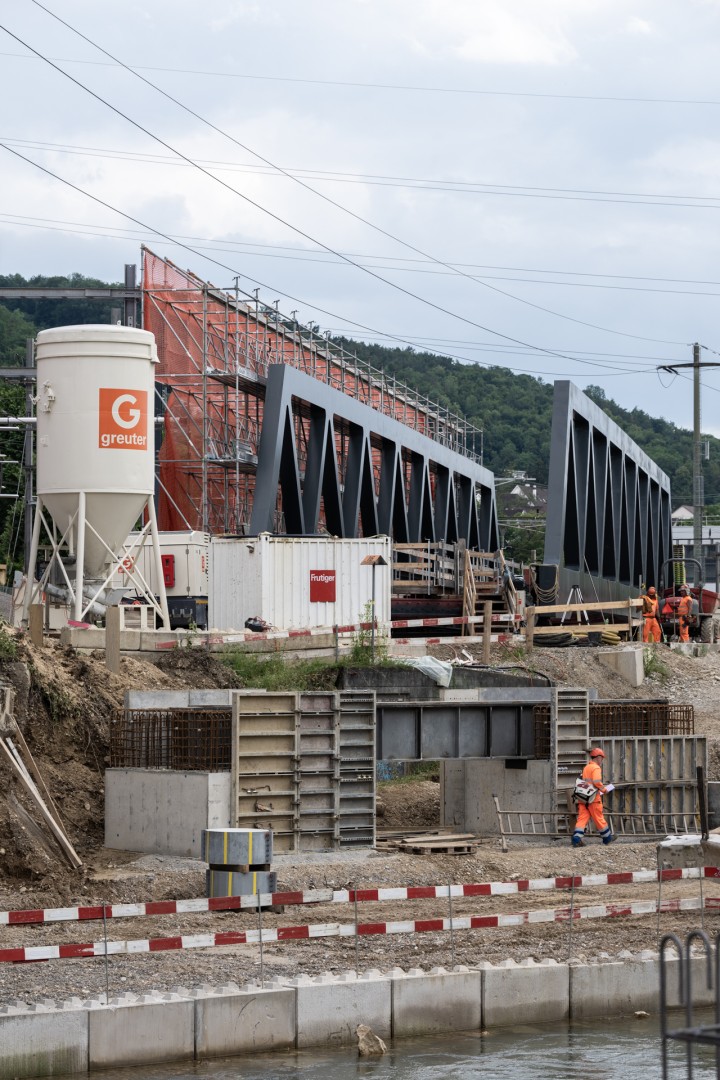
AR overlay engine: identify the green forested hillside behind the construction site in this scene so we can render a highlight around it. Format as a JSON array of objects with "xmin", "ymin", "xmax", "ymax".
[{"xmin": 0, "ymin": 273, "xmax": 720, "ymax": 558}]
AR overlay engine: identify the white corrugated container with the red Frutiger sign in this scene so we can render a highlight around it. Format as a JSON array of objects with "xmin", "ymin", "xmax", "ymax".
[{"xmin": 208, "ymin": 532, "xmax": 392, "ymax": 630}]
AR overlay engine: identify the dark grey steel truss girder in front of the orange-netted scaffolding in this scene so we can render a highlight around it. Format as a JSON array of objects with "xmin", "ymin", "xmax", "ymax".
[{"xmin": 250, "ymin": 364, "xmax": 498, "ymax": 551}]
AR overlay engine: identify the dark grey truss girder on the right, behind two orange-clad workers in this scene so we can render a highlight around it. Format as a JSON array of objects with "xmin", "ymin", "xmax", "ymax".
[{"xmin": 544, "ymin": 381, "xmax": 671, "ymax": 602}]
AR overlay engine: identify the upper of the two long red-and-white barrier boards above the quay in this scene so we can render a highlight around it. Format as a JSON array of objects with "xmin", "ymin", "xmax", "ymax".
[{"xmin": 0, "ymin": 866, "xmax": 708, "ymax": 926}]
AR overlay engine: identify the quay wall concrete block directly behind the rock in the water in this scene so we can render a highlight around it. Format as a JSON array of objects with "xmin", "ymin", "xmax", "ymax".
[{"xmin": 290, "ymin": 978, "xmax": 392, "ymax": 1050}]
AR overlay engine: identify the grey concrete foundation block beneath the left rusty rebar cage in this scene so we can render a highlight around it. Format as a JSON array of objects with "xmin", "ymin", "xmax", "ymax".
[{"xmin": 105, "ymin": 768, "xmax": 232, "ymax": 859}]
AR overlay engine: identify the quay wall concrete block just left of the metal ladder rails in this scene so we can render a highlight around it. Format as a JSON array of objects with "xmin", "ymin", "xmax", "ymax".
[{"xmin": 570, "ymin": 959, "xmax": 660, "ymax": 1020}]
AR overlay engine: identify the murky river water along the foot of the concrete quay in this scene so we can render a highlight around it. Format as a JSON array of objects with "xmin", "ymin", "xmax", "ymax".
[{"xmin": 64, "ymin": 1012, "xmax": 720, "ymax": 1080}]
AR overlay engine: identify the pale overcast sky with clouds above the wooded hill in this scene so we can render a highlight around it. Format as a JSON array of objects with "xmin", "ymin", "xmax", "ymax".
[{"xmin": 0, "ymin": 0, "xmax": 720, "ymax": 433}]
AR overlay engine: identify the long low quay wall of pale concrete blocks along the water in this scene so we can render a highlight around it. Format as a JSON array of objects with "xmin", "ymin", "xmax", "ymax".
[{"xmin": 0, "ymin": 953, "xmax": 714, "ymax": 1080}]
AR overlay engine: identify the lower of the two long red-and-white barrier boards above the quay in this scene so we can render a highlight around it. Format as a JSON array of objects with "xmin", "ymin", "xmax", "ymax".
[{"xmin": 0, "ymin": 896, "xmax": 720, "ymax": 963}]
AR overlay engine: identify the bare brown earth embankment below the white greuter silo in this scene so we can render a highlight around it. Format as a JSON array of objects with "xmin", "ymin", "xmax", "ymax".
[{"xmin": 0, "ymin": 636, "xmax": 241, "ymax": 899}]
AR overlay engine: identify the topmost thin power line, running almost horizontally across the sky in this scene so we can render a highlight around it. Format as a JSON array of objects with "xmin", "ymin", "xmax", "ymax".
[{"xmin": 0, "ymin": 53, "xmax": 720, "ymax": 106}]
